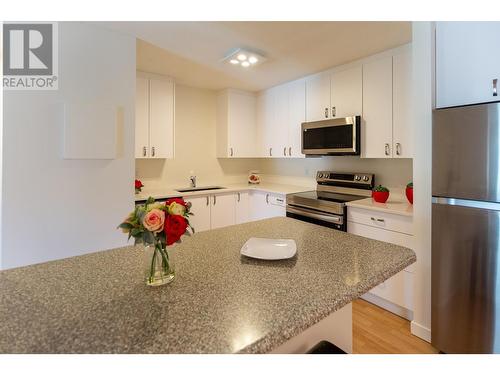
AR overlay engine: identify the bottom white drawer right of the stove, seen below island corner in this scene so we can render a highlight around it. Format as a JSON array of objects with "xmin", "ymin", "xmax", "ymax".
[{"xmin": 364, "ymin": 270, "xmax": 413, "ymax": 311}]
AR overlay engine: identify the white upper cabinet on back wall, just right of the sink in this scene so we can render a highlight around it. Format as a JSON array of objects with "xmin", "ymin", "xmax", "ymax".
[{"xmin": 216, "ymin": 89, "xmax": 257, "ymax": 158}]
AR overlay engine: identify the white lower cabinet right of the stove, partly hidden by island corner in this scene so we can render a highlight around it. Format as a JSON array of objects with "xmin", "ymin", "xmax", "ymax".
[{"xmin": 347, "ymin": 207, "xmax": 414, "ymax": 319}]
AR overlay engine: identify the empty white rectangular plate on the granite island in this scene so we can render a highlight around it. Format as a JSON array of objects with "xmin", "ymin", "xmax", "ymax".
[{"xmin": 240, "ymin": 237, "xmax": 297, "ymax": 260}]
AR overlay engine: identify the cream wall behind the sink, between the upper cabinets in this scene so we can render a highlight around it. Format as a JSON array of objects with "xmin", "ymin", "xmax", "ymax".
[{"xmin": 135, "ymin": 85, "xmax": 259, "ymax": 190}]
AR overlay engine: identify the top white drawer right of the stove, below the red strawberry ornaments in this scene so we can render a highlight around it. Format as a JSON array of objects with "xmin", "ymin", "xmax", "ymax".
[{"xmin": 347, "ymin": 207, "xmax": 413, "ymax": 235}]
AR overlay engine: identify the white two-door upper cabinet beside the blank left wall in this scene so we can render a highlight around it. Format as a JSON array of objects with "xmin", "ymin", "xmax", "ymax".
[{"xmin": 135, "ymin": 74, "xmax": 175, "ymax": 159}]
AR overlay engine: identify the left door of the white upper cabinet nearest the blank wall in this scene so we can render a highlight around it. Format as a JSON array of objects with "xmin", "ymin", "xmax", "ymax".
[{"xmin": 135, "ymin": 77, "xmax": 150, "ymax": 158}]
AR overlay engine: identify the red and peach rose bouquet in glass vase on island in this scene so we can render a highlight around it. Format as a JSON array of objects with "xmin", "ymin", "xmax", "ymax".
[{"xmin": 118, "ymin": 197, "xmax": 194, "ymax": 286}]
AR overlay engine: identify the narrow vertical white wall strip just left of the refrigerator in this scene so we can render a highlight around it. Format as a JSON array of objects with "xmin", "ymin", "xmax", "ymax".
[{"xmin": 411, "ymin": 22, "xmax": 434, "ymax": 341}]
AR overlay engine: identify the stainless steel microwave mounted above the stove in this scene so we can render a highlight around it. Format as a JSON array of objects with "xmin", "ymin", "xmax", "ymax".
[{"xmin": 302, "ymin": 116, "xmax": 361, "ymax": 155}]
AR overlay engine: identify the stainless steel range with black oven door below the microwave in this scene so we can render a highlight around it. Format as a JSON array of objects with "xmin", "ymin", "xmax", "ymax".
[{"xmin": 286, "ymin": 171, "xmax": 375, "ymax": 232}]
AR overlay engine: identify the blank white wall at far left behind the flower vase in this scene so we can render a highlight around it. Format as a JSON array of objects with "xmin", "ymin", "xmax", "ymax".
[{"xmin": 1, "ymin": 22, "xmax": 135, "ymax": 268}]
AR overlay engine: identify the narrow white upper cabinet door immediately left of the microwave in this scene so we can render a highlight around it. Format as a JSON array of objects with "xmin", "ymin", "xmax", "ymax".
[{"xmin": 287, "ymin": 79, "xmax": 306, "ymax": 158}]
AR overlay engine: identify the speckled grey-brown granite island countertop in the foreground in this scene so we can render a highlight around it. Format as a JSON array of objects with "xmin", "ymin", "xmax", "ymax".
[{"xmin": 0, "ymin": 218, "xmax": 416, "ymax": 353}]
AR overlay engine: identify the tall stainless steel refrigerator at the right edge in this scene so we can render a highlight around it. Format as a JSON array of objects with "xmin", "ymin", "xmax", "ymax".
[{"xmin": 432, "ymin": 103, "xmax": 500, "ymax": 353}]
